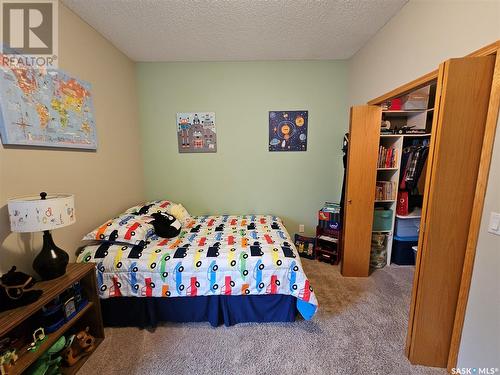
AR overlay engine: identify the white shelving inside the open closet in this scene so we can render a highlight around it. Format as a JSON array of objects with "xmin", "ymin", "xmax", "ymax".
[{"xmin": 372, "ymin": 83, "xmax": 436, "ymax": 265}]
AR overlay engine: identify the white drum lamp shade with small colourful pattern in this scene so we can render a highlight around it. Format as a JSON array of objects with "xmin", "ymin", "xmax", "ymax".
[{"xmin": 7, "ymin": 194, "xmax": 76, "ymax": 232}]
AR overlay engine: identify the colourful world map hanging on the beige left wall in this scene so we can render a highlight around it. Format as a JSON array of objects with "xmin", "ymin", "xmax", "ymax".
[{"xmin": 0, "ymin": 66, "xmax": 97, "ymax": 150}]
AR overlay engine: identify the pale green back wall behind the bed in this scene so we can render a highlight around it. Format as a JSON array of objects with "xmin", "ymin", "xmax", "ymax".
[{"xmin": 137, "ymin": 61, "xmax": 348, "ymax": 235}]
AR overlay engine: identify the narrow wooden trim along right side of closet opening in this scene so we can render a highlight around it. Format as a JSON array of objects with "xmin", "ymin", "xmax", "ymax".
[{"xmin": 448, "ymin": 46, "xmax": 500, "ymax": 372}]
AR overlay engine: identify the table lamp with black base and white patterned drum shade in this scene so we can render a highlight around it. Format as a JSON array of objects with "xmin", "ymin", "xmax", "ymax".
[{"xmin": 7, "ymin": 193, "xmax": 76, "ymax": 280}]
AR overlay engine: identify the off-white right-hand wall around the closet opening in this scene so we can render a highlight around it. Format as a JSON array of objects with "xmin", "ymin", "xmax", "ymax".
[{"xmin": 349, "ymin": 0, "xmax": 500, "ymax": 368}]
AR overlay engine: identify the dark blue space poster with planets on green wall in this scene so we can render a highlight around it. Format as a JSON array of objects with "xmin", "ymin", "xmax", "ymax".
[{"xmin": 269, "ymin": 111, "xmax": 308, "ymax": 151}]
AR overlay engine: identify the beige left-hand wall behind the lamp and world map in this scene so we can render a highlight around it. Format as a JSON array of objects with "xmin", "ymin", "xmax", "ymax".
[{"xmin": 0, "ymin": 4, "xmax": 144, "ymax": 273}]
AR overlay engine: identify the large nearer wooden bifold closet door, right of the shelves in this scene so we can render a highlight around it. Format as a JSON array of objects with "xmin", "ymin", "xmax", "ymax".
[{"xmin": 406, "ymin": 56, "xmax": 495, "ymax": 367}]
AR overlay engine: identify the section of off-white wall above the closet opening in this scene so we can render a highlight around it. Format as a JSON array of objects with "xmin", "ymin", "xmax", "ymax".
[{"xmin": 349, "ymin": 0, "xmax": 500, "ymax": 104}]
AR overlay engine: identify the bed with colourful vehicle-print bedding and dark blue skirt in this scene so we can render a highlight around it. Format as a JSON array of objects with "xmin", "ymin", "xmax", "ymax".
[{"xmin": 77, "ymin": 201, "xmax": 318, "ymax": 326}]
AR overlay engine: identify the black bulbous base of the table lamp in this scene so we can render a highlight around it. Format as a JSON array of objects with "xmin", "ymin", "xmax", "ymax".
[{"xmin": 33, "ymin": 230, "xmax": 69, "ymax": 280}]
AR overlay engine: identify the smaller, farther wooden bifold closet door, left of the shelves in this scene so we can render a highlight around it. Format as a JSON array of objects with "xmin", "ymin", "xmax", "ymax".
[{"xmin": 341, "ymin": 105, "xmax": 382, "ymax": 276}]
